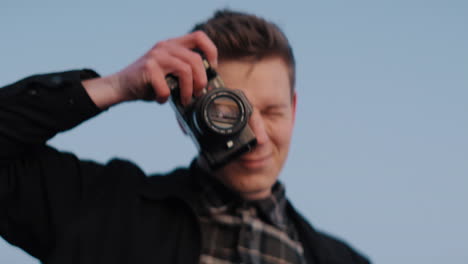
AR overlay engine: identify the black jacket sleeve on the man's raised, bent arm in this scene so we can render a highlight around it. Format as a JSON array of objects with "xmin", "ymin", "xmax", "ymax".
[{"xmin": 0, "ymin": 70, "xmax": 102, "ymax": 259}]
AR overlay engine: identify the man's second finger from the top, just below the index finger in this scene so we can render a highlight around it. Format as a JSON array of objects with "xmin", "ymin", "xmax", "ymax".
[{"xmin": 168, "ymin": 45, "xmax": 208, "ymax": 95}]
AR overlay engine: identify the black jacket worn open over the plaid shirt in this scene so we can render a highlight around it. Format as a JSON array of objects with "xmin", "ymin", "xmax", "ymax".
[{"xmin": 0, "ymin": 70, "xmax": 368, "ymax": 264}]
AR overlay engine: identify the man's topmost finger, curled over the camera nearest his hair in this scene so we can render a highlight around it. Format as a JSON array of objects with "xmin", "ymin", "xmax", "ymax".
[{"xmin": 172, "ymin": 31, "xmax": 218, "ymax": 67}]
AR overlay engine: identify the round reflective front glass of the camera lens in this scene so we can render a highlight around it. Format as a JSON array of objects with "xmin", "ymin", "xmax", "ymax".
[{"xmin": 207, "ymin": 96, "xmax": 240, "ymax": 129}]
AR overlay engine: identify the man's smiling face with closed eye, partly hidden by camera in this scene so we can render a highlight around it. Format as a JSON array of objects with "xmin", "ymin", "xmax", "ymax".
[{"xmin": 213, "ymin": 57, "xmax": 296, "ymax": 199}]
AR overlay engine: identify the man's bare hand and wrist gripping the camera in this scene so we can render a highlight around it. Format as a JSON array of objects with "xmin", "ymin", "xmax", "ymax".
[{"xmin": 83, "ymin": 31, "xmax": 218, "ymax": 108}]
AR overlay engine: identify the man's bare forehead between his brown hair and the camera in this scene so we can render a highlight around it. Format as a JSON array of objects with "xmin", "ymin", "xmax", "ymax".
[{"xmin": 217, "ymin": 58, "xmax": 291, "ymax": 105}]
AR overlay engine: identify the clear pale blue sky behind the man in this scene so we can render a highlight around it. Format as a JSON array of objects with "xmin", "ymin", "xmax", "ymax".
[{"xmin": 0, "ymin": 0, "xmax": 468, "ymax": 264}]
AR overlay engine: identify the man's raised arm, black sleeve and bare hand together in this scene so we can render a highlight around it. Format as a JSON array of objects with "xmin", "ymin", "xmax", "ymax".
[{"xmin": 0, "ymin": 32, "xmax": 217, "ymax": 262}]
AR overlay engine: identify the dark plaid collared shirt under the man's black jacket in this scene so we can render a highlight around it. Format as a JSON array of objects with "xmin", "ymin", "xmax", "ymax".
[{"xmin": 191, "ymin": 169, "xmax": 305, "ymax": 264}]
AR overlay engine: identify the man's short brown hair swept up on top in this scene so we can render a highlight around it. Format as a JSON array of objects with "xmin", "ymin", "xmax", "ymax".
[{"xmin": 192, "ymin": 9, "xmax": 296, "ymax": 93}]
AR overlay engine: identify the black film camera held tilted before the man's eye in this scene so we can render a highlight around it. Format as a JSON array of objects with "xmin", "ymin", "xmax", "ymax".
[{"xmin": 166, "ymin": 56, "xmax": 257, "ymax": 169}]
